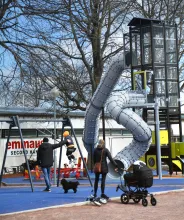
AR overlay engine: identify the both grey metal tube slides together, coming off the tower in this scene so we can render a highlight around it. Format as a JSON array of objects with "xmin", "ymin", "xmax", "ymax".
[{"xmin": 83, "ymin": 55, "xmax": 151, "ymax": 178}]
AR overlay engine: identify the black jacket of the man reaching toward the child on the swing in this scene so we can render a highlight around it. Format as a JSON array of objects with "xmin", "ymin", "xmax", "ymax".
[{"xmin": 37, "ymin": 141, "xmax": 67, "ymax": 167}]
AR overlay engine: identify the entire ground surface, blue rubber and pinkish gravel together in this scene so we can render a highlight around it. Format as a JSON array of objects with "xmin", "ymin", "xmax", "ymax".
[{"xmin": 0, "ymin": 175, "xmax": 184, "ymax": 220}]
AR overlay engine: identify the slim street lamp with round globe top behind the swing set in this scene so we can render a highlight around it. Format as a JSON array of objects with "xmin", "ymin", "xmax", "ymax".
[{"xmin": 50, "ymin": 87, "xmax": 59, "ymax": 184}]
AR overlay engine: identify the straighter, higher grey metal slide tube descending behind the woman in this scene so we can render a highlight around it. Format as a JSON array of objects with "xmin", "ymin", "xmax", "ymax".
[{"xmin": 83, "ymin": 55, "xmax": 124, "ymax": 152}]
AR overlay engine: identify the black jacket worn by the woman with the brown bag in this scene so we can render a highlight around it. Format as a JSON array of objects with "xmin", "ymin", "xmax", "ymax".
[{"xmin": 93, "ymin": 146, "xmax": 117, "ymax": 173}]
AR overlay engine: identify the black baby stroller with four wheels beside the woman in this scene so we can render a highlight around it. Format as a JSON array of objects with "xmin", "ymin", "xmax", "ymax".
[{"xmin": 116, "ymin": 161, "xmax": 157, "ymax": 206}]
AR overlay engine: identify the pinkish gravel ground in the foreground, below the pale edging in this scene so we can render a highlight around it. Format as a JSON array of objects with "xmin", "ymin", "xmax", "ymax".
[{"xmin": 0, "ymin": 191, "xmax": 184, "ymax": 220}]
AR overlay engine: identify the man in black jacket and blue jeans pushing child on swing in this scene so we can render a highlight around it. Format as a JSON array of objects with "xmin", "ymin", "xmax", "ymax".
[{"xmin": 37, "ymin": 137, "xmax": 67, "ymax": 192}]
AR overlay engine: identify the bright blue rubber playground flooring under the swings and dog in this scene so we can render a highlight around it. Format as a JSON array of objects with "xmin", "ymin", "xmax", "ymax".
[{"xmin": 0, "ymin": 177, "xmax": 184, "ymax": 214}]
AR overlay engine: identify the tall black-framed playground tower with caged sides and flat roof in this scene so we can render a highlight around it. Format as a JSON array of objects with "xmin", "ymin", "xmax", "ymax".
[{"xmin": 124, "ymin": 18, "xmax": 182, "ymax": 174}]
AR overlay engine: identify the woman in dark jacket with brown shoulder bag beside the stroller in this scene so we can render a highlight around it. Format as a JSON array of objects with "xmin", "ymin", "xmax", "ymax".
[{"xmin": 93, "ymin": 140, "xmax": 118, "ymax": 200}]
